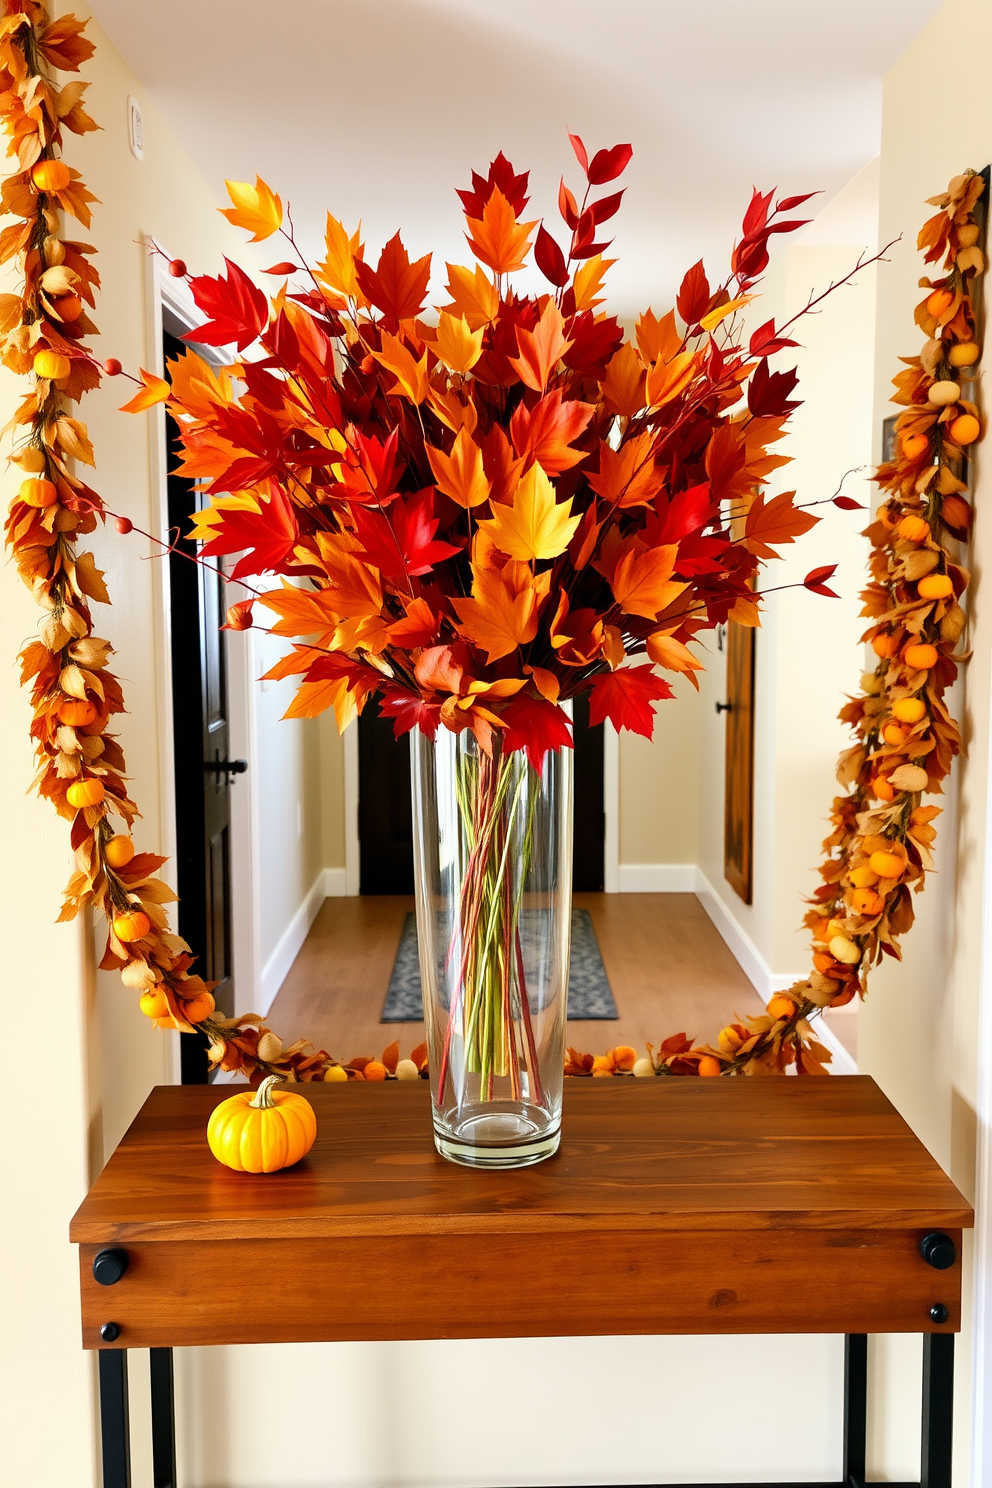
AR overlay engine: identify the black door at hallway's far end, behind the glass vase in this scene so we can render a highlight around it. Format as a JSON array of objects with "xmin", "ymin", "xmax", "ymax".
[{"xmin": 358, "ymin": 698, "xmax": 605, "ymax": 894}]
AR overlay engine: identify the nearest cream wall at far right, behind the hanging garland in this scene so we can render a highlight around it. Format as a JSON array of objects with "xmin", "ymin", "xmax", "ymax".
[{"xmin": 858, "ymin": 0, "xmax": 992, "ymax": 1488}]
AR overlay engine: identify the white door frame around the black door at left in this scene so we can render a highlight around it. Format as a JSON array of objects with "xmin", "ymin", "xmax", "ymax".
[{"xmin": 143, "ymin": 235, "xmax": 262, "ymax": 1041}]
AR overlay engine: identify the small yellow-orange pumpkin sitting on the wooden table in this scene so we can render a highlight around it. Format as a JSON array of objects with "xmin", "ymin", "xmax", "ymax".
[{"xmin": 207, "ymin": 1074, "xmax": 317, "ymax": 1173}]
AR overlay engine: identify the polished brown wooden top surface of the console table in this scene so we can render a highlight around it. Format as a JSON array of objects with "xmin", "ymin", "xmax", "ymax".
[{"xmin": 70, "ymin": 1076, "xmax": 973, "ymax": 1244}]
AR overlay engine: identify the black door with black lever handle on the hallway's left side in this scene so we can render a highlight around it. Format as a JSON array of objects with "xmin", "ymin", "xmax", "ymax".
[{"xmin": 164, "ymin": 333, "xmax": 237, "ymax": 1083}]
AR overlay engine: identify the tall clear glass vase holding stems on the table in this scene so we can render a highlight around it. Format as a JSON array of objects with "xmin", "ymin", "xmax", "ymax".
[{"xmin": 410, "ymin": 726, "xmax": 571, "ymax": 1168}]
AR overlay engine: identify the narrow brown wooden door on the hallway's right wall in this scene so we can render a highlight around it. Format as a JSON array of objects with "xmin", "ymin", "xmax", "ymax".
[{"xmin": 723, "ymin": 620, "xmax": 754, "ymax": 905}]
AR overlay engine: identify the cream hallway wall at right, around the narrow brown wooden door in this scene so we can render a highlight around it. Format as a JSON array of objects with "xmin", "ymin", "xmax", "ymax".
[{"xmin": 699, "ymin": 168, "xmax": 876, "ymax": 985}]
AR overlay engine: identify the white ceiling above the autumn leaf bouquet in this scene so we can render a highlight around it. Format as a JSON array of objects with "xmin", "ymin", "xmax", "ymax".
[{"xmin": 92, "ymin": 0, "xmax": 940, "ymax": 315}]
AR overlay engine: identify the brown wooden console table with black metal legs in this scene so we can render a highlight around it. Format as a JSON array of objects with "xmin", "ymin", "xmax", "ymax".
[{"xmin": 70, "ymin": 1076, "xmax": 973, "ymax": 1488}]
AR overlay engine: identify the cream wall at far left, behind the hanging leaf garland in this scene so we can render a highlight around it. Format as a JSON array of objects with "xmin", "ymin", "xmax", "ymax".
[{"xmin": 0, "ymin": 3, "xmax": 323, "ymax": 1488}]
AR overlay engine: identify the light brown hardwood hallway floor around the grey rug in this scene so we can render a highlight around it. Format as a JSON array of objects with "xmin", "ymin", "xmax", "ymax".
[{"xmin": 269, "ymin": 894, "xmax": 761, "ymax": 1059}]
